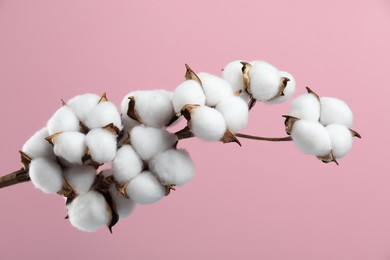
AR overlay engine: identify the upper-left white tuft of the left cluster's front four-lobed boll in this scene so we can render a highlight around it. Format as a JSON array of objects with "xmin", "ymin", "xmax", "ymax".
[{"xmin": 46, "ymin": 106, "xmax": 80, "ymax": 135}]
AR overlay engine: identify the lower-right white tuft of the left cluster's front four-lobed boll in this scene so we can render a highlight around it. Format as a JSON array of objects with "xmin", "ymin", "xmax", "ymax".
[{"xmin": 85, "ymin": 128, "xmax": 117, "ymax": 163}]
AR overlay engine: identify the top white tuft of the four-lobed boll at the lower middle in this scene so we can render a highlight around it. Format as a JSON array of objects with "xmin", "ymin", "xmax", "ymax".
[{"xmin": 130, "ymin": 126, "xmax": 177, "ymax": 161}]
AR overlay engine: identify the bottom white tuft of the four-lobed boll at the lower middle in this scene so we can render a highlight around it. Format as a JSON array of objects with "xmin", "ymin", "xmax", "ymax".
[{"xmin": 126, "ymin": 171, "xmax": 166, "ymax": 204}]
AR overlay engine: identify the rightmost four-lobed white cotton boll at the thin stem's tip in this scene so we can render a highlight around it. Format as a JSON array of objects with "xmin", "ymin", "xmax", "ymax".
[{"xmin": 285, "ymin": 88, "xmax": 360, "ymax": 164}]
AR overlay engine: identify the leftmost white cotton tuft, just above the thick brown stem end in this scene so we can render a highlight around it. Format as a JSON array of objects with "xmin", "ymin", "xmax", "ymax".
[{"xmin": 22, "ymin": 127, "xmax": 55, "ymax": 159}]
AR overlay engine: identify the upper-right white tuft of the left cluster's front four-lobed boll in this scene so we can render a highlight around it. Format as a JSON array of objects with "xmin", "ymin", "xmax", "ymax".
[{"xmin": 84, "ymin": 101, "xmax": 122, "ymax": 129}]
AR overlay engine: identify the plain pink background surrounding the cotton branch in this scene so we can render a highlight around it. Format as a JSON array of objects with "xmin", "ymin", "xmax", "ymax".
[{"xmin": 0, "ymin": 0, "xmax": 390, "ymax": 260}]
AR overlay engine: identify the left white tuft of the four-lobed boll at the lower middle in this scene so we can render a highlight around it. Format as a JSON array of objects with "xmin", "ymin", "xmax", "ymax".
[{"xmin": 112, "ymin": 144, "xmax": 143, "ymax": 183}]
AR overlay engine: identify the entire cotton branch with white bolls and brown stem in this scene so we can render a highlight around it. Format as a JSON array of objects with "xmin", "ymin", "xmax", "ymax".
[{"xmin": 0, "ymin": 61, "xmax": 360, "ymax": 232}]
